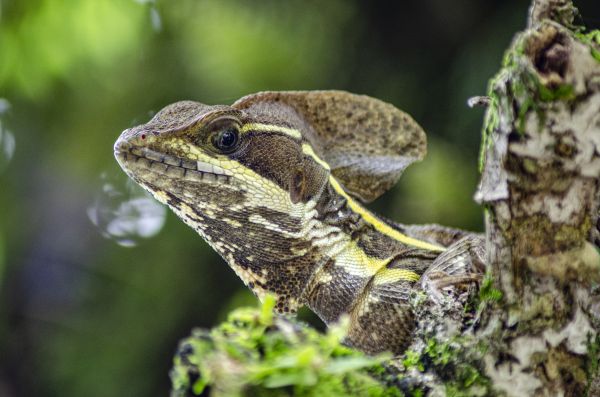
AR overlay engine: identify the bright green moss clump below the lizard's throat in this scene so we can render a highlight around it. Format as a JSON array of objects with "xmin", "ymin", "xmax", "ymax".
[{"xmin": 171, "ymin": 298, "xmax": 402, "ymax": 397}]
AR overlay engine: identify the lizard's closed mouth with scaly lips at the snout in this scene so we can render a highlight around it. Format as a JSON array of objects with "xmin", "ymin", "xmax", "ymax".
[{"xmin": 114, "ymin": 141, "xmax": 233, "ymax": 183}]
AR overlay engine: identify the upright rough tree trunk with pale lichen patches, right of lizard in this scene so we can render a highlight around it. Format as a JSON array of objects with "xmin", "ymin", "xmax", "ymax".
[{"xmin": 476, "ymin": 0, "xmax": 600, "ymax": 396}]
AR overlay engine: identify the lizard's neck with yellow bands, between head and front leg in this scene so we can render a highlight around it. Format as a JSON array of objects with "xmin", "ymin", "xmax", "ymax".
[{"xmin": 302, "ymin": 181, "xmax": 440, "ymax": 324}]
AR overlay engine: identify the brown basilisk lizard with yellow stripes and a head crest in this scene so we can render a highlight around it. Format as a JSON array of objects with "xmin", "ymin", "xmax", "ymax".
[{"xmin": 114, "ymin": 91, "xmax": 482, "ymax": 353}]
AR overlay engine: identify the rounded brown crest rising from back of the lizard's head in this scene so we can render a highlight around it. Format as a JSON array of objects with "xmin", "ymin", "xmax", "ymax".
[{"xmin": 233, "ymin": 91, "xmax": 427, "ymax": 202}]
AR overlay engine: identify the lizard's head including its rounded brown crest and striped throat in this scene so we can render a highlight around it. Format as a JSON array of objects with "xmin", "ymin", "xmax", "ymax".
[{"xmin": 114, "ymin": 91, "xmax": 425, "ymax": 312}]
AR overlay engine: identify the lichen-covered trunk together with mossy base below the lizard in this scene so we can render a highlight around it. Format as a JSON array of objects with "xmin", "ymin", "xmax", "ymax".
[{"xmin": 172, "ymin": 0, "xmax": 600, "ymax": 396}]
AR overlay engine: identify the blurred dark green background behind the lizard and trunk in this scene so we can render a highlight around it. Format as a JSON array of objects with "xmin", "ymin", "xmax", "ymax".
[{"xmin": 0, "ymin": 0, "xmax": 600, "ymax": 397}]
